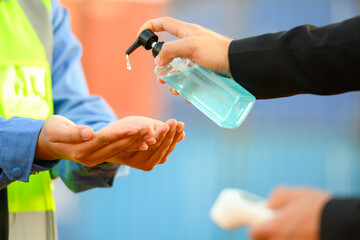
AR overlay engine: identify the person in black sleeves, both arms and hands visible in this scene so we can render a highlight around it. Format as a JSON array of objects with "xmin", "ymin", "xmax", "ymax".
[{"xmin": 139, "ymin": 17, "xmax": 360, "ymax": 240}]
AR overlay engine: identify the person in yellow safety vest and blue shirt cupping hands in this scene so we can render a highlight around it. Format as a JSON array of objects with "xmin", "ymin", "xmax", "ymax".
[{"xmin": 0, "ymin": 0, "xmax": 184, "ymax": 240}]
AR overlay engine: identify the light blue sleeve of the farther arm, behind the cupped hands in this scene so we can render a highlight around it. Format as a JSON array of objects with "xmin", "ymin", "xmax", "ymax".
[{"xmin": 51, "ymin": 0, "xmax": 128, "ymax": 192}]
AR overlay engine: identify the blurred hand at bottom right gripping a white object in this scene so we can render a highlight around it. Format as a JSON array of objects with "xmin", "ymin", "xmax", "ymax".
[{"xmin": 251, "ymin": 187, "xmax": 331, "ymax": 240}]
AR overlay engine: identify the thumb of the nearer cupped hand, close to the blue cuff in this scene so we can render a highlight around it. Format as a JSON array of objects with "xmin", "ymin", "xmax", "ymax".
[{"xmin": 45, "ymin": 117, "xmax": 94, "ymax": 143}]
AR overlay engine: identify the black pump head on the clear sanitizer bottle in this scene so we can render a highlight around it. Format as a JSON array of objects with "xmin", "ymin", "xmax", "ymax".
[{"xmin": 126, "ymin": 29, "xmax": 164, "ymax": 57}]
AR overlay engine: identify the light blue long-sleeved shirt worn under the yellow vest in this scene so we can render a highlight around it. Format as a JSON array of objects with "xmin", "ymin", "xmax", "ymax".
[{"xmin": 0, "ymin": 0, "xmax": 128, "ymax": 192}]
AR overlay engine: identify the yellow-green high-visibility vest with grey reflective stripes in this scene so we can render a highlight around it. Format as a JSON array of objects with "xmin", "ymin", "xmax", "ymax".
[{"xmin": 0, "ymin": 0, "xmax": 57, "ymax": 240}]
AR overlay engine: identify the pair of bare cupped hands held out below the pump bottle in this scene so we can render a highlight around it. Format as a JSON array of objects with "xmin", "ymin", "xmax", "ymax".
[{"xmin": 35, "ymin": 115, "xmax": 185, "ymax": 171}]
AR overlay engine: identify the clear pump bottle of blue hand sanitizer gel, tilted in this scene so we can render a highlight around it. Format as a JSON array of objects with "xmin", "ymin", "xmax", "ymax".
[{"xmin": 126, "ymin": 29, "xmax": 255, "ymax": 128}]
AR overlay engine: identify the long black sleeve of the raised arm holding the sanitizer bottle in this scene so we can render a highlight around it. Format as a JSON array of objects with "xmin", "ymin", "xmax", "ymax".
[{"xmin": 229, "ymin": 16, "xmax": 360, "ymax": 99}]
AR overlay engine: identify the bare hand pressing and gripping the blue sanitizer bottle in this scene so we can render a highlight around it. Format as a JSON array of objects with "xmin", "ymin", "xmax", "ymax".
[{"xmin": 138, "ymin": 17, "xmax": 232, "ymax": 98}]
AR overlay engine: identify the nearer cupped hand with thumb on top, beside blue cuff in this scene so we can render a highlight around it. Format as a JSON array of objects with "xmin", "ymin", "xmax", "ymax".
[{"xmin": 35, "ymin": 115, "xmax": 184, "ymax": 167}]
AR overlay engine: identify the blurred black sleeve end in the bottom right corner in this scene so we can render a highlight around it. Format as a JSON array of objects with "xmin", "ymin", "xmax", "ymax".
[{"xmin": 320, "ymin": 199, "xmax": 360, "ymax": 240}]
